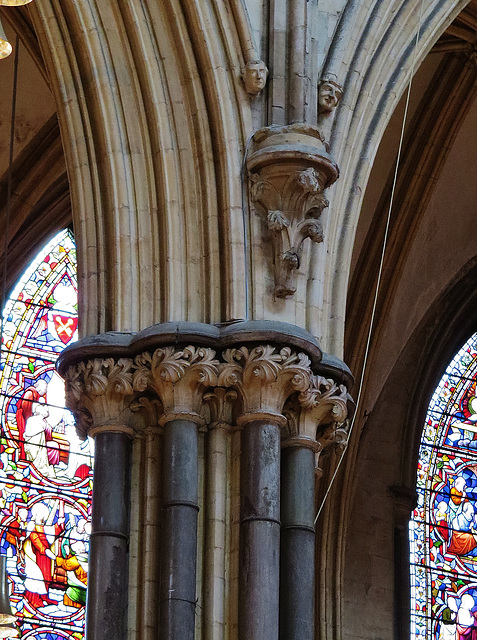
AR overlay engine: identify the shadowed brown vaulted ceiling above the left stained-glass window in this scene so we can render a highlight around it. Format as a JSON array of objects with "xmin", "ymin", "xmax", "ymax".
[{"xmin": 0, "ymin": 6, "xmax": 71, "ymax": 284}]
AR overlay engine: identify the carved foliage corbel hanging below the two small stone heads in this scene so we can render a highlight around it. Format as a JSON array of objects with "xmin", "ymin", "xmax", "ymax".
[{"xmin": 247, "ymin": 124, "xmax": 339, "ymax": 298}]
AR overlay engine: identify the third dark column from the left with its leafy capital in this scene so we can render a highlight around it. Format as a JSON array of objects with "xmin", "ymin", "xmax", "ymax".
[{"xmin": 219, "ymin": 345, "xmax": 311, "ymax": 640}]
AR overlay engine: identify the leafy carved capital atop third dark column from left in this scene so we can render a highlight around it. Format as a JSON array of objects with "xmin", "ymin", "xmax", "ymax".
[{"xmin": 218, "ymin": 344, "xmax": 312, "ymax": 425}]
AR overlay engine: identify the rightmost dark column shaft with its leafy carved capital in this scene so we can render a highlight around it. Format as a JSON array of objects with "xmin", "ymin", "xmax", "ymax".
[{"xmin": 280, "ymin": 376, "xmax": 347, "ymax": 640}]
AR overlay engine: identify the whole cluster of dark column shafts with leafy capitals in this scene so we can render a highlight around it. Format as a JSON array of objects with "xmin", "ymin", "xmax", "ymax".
[{"xmin": 60, "ymin": 322, "xmax": 347, "ymax": 640}]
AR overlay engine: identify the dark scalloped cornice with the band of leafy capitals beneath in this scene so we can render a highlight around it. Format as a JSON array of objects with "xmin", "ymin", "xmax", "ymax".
[{"xmin": 57, "ymin": 321, "xmax": 352, "ymax": 433}]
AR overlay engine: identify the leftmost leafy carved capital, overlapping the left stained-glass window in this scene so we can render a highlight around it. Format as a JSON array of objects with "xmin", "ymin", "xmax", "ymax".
[{"xmin": 65, "ymin": 358, "xmax": 136, "ymax": 437}]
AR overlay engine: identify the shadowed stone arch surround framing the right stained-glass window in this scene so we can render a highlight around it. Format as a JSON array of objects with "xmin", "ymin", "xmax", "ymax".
[{"xmin": 342, "ymin": 259, "xmax": 477, "ymax": 638}]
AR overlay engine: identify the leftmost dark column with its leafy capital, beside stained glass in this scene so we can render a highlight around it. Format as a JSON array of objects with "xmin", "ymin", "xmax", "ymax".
[{"xmin": 61, "ymin": 358, "xmax": 137, "ymax": 640}]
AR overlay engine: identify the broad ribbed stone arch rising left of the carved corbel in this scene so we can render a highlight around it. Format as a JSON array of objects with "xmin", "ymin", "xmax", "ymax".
[{"xmin": 27, "ymin": 0, "xmax": 250, "ymax": 335}]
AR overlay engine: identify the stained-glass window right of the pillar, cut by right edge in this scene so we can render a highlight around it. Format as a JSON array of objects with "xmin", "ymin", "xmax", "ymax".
[{"xmin": 410, "ymin": 334, "xmax": 477, "ymax": 640}]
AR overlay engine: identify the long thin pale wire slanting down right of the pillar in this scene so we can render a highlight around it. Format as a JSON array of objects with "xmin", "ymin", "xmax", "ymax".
[{"xmin": 314, "ymin": 0, "xmax": 424, "ymax": 525}]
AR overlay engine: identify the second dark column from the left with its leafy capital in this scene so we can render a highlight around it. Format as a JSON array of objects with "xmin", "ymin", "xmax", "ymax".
[{"xmin": 134, "ymin": 346, "xmax": 218, "ymax": 640}]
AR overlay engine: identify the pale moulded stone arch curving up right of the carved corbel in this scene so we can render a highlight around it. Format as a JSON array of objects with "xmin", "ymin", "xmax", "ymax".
[{"xmin": 316, "ymin": 0, "xmax": 467, "ymax": 354}]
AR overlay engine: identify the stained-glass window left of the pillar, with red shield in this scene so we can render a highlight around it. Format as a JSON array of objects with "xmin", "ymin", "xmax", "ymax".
[{"xmin": 0, "ymin": 231, "xmax": 92, "ymax": 640}]
